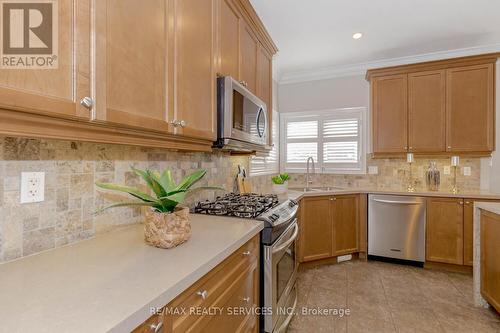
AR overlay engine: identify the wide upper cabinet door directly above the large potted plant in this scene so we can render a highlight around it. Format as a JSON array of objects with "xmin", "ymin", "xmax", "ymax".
[{"xmin": 95, "ymin": 0, "xmax": 170, "ymax": 132}]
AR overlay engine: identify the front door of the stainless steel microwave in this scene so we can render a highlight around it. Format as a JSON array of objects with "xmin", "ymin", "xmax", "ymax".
[{"xmin": 219, "ymin": 77, "xmax": 268, "ymax": 145}]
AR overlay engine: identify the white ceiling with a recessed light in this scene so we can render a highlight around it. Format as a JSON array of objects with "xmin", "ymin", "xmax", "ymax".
[{"xmin": 251, "ymin": 0, "xmax": 500, "ymax": 81}]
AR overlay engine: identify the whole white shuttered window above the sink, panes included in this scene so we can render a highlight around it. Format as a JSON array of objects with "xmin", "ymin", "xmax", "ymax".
[{"xmin": 281, "ymin": 108, "xmax": 366, "ymax": 173}]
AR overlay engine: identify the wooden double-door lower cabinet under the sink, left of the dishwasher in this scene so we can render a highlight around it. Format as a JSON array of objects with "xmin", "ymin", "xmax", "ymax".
[{"xmin": 299, "ymin": 194, "xmax": 360, "ymax": 262}]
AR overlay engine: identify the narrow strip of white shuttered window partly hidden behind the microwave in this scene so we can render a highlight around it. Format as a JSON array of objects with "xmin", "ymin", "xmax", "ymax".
[{"xmin": 250, "ymin": 110, "xmax": 280, "ymax": 176}]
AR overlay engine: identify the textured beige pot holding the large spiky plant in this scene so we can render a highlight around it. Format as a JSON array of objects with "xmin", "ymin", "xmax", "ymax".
[{"xmin": 144, "ymin": 207, "xmax": 191, "ymax": 249}]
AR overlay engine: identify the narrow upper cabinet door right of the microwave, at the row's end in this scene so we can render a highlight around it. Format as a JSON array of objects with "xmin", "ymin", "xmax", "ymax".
[{"xmin": 257, "ymin": 45, "xmax": 273, "ymax": 144}]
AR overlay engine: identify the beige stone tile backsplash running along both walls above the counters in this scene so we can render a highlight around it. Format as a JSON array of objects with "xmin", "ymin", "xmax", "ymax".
[{"xmin": 0, "ymin": 137, "xmax": 480, "ymax": 263}]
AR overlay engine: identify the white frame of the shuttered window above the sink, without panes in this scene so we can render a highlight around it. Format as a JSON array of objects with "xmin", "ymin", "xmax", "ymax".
[{"xmin": 279, "ymin": 107, "xmax": 368, "ymax": 174}]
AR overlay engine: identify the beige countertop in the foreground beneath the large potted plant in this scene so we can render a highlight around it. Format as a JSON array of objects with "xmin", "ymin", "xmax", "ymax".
[{"xmin": 0, "ymin": 214, "xmax": 263, "ymax": 333}]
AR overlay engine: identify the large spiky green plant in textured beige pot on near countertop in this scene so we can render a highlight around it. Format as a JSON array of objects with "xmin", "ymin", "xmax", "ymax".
[{"xmin": 96, "ymin": 167, "xmax": 223, "ymax": 249}]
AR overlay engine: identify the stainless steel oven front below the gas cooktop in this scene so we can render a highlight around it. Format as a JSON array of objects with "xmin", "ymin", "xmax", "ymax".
[{"xmin": 264, "ymin": 219, "xmax": 299, "ymax": 332}]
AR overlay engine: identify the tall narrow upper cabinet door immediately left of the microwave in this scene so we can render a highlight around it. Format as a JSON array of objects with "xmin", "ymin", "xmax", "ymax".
[{"xmin": 169, "ymin": 0, "xmax": 217, "ymax": 140}]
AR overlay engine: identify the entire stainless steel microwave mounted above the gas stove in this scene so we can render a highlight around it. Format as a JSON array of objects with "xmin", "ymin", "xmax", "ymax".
[{"xmin": 214, "ymin": 76, "xmax": 268, "ymax": 151}]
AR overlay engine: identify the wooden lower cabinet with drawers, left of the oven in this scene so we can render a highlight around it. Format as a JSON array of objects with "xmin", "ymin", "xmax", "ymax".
[{"xmin": 164, "ymin": 236, "xmax": 260, "ymax": 333}]
